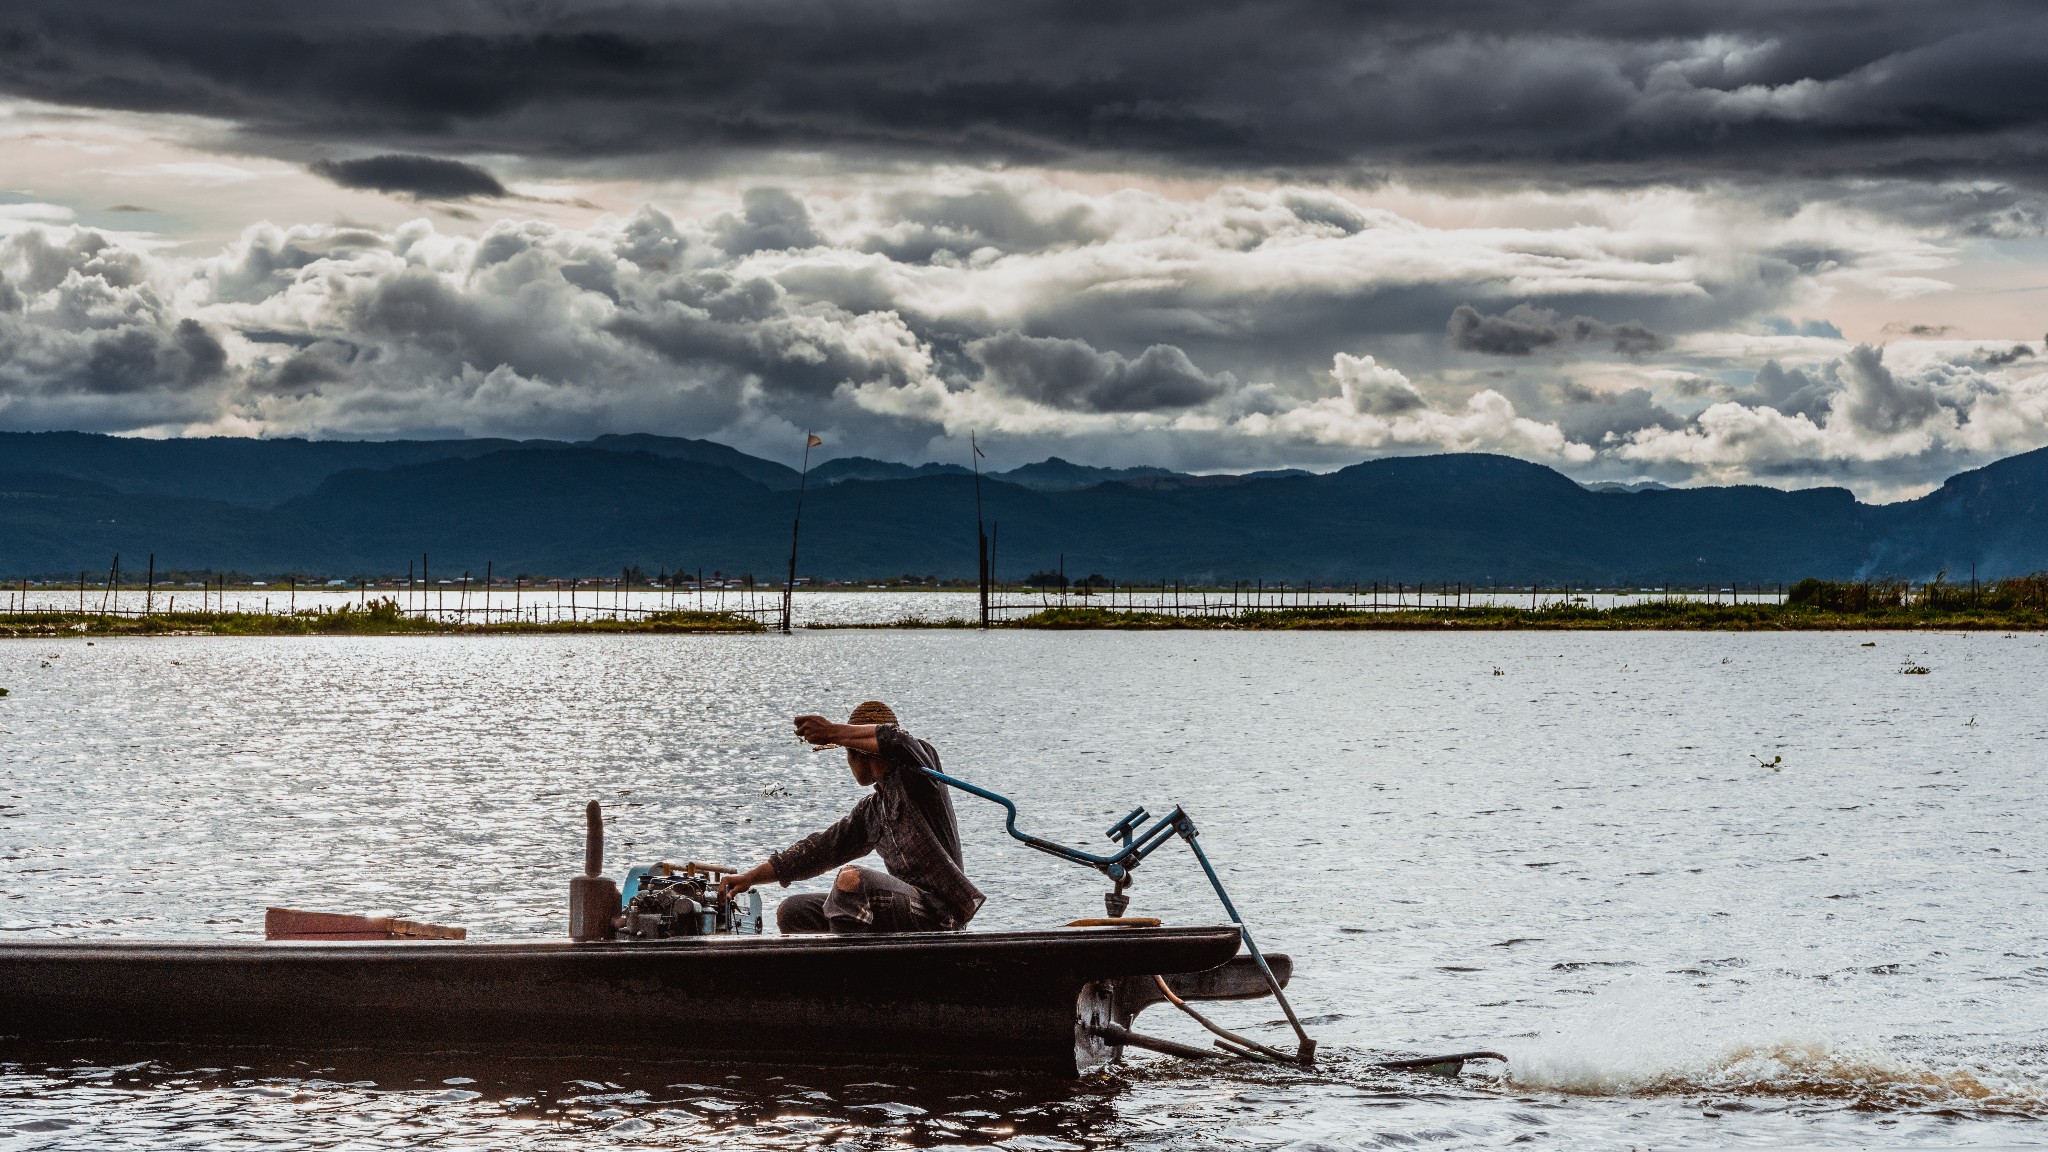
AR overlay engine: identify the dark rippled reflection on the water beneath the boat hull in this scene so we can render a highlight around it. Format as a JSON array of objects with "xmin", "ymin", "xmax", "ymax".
[{"xmin": 0, "ymin": 1043, "xmax": 1126, "ymax": 1150}]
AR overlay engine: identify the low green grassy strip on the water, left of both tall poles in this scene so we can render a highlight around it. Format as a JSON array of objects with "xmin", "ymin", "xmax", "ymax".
[{"xmin": 0, "ymin": 601, "xmax": 766, "ymax": 637}]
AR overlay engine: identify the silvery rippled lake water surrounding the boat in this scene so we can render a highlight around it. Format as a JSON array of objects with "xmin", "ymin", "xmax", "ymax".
[{"xmin": 0, "ymin": 631, "xmax": 2048, "ymax": 1152}]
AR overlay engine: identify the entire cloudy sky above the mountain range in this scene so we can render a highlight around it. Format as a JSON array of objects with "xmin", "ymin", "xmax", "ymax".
[{"xmin": 0, "ymin": 0, "xmax": 2048, "ymax": 500}]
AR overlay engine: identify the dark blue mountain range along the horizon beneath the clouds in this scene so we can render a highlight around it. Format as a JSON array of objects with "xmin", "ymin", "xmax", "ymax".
[{"xmin": 0, "ymin": 433, "xmax": 2048, "ymax": 586}]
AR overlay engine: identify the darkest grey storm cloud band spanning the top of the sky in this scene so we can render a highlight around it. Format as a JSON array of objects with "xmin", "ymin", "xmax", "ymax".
[{"xmin": 0, "ymin": 0, "xmax": 2048, "ymax": 184}]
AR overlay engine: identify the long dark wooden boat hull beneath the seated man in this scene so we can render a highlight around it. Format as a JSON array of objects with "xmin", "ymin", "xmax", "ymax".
[{"xmin": 0, "ymin": 924, "xmax": 1239, "ymax": 1074}]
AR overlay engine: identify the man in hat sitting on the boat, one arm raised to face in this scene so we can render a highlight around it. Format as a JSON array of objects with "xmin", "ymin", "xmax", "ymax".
[{"xmin": 719, "ymin": 701, "xmax": 983, "ymax": 933}]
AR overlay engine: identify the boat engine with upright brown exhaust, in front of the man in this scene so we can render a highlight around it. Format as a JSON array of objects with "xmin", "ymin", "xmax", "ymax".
[{"xmin": 569, "ymin": 799, "xmax": 762, "ymax": 941}]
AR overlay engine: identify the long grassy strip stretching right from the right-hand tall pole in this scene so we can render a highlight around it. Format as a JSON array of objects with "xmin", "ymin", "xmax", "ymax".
[{"xmin": 1004, "ymin": 601, "xmax": 2048, "ymax": 631}]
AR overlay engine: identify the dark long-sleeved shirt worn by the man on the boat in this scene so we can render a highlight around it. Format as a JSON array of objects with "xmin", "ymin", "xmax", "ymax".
[{"xmin": 768, "ymin": 724, "xmax": 987, "ymax": 929}]
